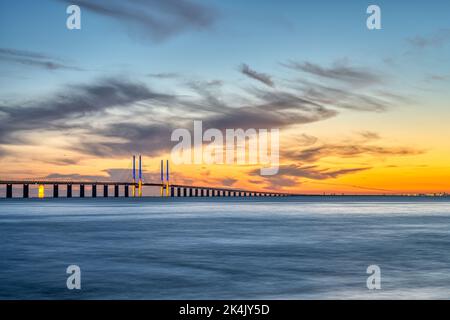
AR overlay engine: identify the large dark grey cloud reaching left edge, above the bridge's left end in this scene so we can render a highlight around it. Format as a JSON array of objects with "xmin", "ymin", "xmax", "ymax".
[{"xmin": 0, "ymin": 78, "xmax": 172, "ymax": 143}]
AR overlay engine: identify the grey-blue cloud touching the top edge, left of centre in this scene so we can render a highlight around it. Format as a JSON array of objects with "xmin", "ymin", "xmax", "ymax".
[{"xmin": 60, "ymin": 0, "xmax": 218, "ymax": 41}]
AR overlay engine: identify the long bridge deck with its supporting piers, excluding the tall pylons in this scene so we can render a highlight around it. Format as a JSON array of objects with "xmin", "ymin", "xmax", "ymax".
[{"xmin": 0, "ymin": 179, "xmax": 293, "ymax": 198}]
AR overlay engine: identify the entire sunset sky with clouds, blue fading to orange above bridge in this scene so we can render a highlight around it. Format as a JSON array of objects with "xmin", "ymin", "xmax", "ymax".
[{"xmin": 0, "ymin": 0, "xmax": 450, "ymax": 194}]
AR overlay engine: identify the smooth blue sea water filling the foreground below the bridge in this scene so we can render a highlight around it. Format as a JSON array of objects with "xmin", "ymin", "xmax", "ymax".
[{"xmin": 0, "ymin": 197, "xmax": 450, "ymax": 299}]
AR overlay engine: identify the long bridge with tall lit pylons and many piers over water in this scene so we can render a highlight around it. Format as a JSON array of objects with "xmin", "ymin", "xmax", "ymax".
[{"xmin": 0, "ymin": 156, "xmax": 293, "ymax": 198}]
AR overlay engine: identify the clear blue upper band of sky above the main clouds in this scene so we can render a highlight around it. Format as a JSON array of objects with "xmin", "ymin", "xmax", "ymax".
[{"xmin": 0, "ymin": 0, "xmax": 450, "ymax": 94}]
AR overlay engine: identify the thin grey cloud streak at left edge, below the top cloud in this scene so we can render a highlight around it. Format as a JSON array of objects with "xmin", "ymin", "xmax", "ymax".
[{"xmin": 0, "ymin": 48, "xmax": 82, "ymax": 71}]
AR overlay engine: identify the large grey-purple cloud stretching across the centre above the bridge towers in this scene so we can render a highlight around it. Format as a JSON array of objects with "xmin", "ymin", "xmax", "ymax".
[{"xmin": 67, "ymin": 82, "xmax": 337, "ymax": 157}]
